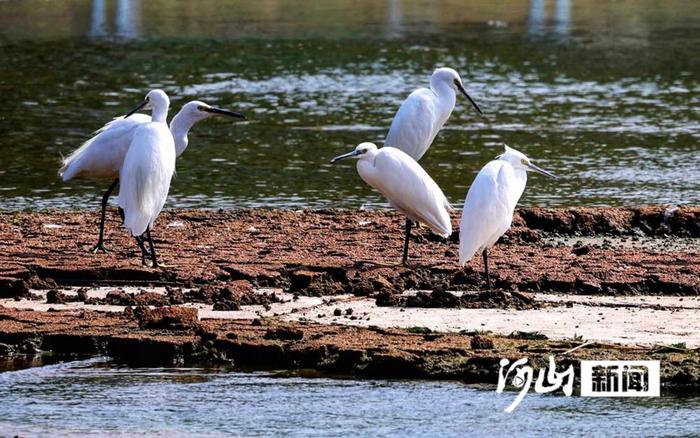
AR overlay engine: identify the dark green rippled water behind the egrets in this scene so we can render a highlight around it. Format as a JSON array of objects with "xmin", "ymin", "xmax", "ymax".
[{"xmin": 0, "ymin": 0, "xmax": 700, "ymax": 209}]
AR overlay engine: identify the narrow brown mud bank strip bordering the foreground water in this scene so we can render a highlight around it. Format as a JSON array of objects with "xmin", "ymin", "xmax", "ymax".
[{"xmin": 0, "ymin": 307, "xmax": 700, "ymax": 392}]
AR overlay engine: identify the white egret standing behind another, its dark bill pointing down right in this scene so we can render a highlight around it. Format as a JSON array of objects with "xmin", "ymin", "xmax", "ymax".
[{"xmin": 384, "ymin": 68, "xmax": 483, "ymax": 161}]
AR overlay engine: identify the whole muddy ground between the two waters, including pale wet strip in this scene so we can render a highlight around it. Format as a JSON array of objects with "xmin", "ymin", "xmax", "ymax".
[{"xmin": 0, "ymin": 207, "xmax": 700, "ymax": 390}]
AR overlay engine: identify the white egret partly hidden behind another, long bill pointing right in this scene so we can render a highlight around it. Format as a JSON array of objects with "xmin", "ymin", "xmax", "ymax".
[{"xmin": 58, "ymin": 100, "xmax": 245, "ymax": 252}]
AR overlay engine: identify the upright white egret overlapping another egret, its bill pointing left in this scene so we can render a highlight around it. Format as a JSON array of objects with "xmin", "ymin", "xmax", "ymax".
[{"xmin": 119, "ymin": 90, "xmax": 175, "ymax": 267}]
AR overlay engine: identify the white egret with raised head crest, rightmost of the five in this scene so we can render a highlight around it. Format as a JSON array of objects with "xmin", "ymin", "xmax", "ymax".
[{"xmin": 459, "ymin": 146, "xmax": 556, "ymax": 290}]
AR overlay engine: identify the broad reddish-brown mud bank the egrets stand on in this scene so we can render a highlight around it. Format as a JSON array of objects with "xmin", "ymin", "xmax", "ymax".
[{"xmin": 0, "ymin": 206, "xmax": 700, "ymax": 300}]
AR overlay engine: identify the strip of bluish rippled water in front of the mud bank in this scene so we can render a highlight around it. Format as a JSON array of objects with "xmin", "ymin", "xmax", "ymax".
[{"xmin": 0, "ymin": 359, "xmax": 700, "ymax": 437}]
